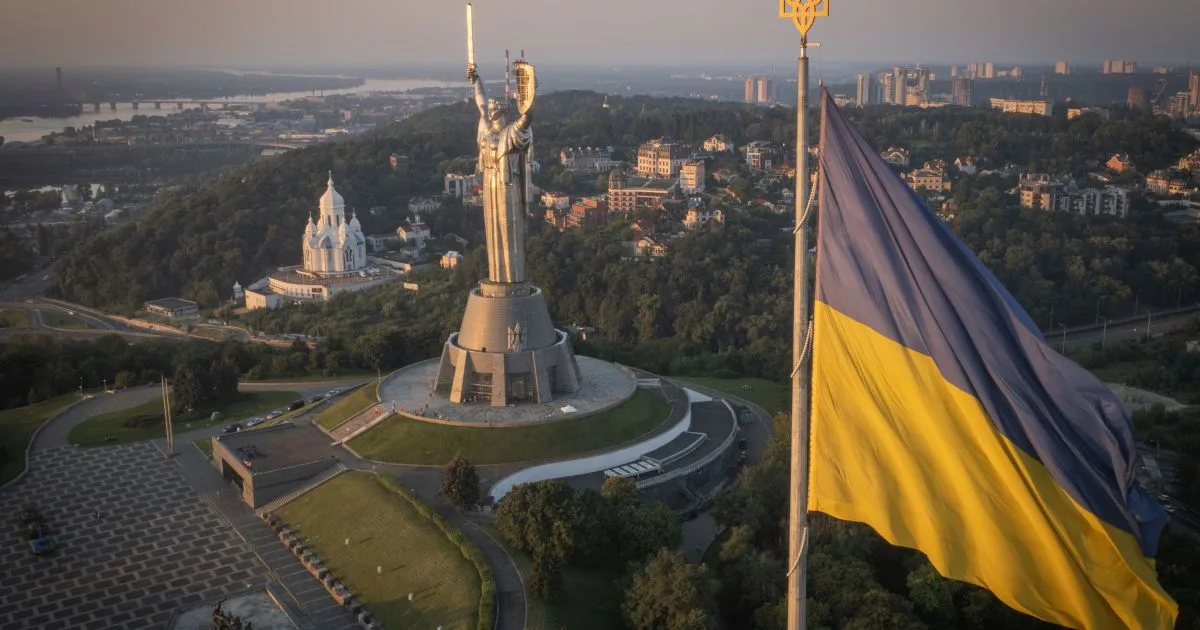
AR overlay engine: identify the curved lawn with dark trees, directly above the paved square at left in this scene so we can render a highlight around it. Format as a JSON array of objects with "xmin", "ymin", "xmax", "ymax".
[{"xmin": 67, "ymin": 391, "xmax": 300, "ymax": 446}]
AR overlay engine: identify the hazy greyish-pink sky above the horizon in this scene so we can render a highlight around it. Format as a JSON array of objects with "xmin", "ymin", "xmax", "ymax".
[{"xmin": 0, "ymin": 0, "xmax": 1200, "ymax": 67}]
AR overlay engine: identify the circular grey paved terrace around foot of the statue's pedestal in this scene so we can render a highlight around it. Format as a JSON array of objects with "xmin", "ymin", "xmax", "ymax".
[{"xmin": 379, "ymin": 356, "xmax": 637, "ymax": 427}]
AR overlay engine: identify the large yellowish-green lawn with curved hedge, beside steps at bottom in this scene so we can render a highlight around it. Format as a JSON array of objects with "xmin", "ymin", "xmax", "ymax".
[{"xmin": 276, "ymin": 472, "xmax": 480, "ymax": 630}]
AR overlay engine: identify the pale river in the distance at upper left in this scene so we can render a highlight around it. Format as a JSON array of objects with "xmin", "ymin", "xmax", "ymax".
[{"xmin": 0, "ymin": 73, "xmax": 467, "ymax": 144}]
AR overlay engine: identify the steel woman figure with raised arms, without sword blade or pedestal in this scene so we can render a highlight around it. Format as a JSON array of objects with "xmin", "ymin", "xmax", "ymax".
[{"xmin": 467, "ymin": 60, "xmax": 534, "ymax": 283}]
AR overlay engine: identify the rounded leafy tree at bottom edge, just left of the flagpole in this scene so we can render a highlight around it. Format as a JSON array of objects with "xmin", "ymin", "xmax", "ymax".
[{"xmin": 622, "ymin": 550, "xmax": 716, "ymax": 630}]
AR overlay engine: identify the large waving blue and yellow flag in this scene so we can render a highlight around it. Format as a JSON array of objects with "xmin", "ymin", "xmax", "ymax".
[{"xmin": 809, "ymin": 89, "xmax": 1178, "ymax": 629}]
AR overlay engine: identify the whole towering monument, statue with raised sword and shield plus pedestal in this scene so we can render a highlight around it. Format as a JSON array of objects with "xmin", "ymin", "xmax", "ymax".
[{"xmin": 434, "ymin": 4, "xmax": 580, "ymax": 407}]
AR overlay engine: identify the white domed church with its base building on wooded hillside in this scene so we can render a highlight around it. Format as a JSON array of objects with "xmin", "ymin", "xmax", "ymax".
[{"xmin": 245, "ymin": 173, "xmax": 400, "ymax": 310}]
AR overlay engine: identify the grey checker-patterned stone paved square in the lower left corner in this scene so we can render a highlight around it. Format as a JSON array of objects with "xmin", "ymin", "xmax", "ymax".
[{"xmin": 0, "ymin": 443, "xmax": 270, "ymax": 629}]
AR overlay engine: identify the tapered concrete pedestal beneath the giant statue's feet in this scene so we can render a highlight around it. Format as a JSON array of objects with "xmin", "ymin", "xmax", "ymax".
[{"xmin": 434, "ymin": 282, "xmax": 580, "ymax": 407}]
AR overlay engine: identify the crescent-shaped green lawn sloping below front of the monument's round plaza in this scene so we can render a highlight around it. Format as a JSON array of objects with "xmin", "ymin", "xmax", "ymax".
[{"xmin": 349, "ymin": 389, "xmax": 671, "ymax": 466}]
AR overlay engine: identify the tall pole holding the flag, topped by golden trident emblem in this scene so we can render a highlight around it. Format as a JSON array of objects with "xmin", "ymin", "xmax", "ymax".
[{"xmin": 779, "ymin": 0, "xmax": 829, "ymax": 630}]
